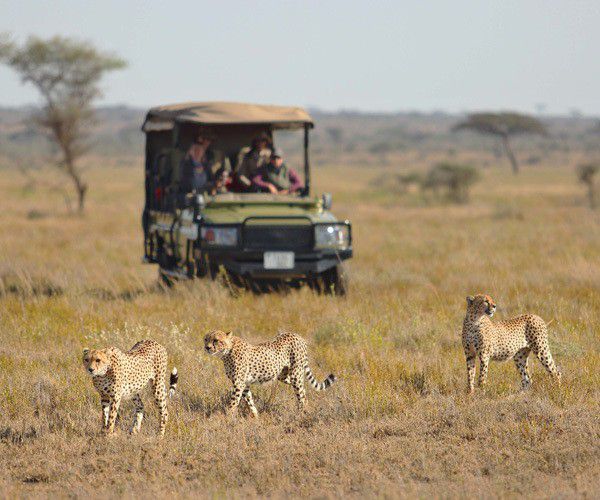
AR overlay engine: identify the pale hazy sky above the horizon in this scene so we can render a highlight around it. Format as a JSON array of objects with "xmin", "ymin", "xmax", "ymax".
[{"xmin": 0, "ymin": 0, "xmax": 600, "ymax": 115}]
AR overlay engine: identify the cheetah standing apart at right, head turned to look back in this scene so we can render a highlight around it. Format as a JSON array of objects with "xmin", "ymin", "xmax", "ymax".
[{"xmin": 462, "ymin": 294, "xmax": 561, "ymax": 393}]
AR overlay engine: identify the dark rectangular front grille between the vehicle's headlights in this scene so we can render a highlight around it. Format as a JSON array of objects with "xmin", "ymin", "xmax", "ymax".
[{"xmin": 243, "ymin": 225, "xmax": 313, "ymax": 250}]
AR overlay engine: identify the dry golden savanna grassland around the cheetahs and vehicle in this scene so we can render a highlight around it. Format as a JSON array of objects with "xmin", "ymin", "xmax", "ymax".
[{"xmin": 0, "ymin": 156, "xmax": 600, "ymax": 497}]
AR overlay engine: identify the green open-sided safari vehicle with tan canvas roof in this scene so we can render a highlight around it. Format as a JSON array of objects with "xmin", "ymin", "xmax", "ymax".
[{"xmin": 142, "ymin": 102, "xmax": 352, "ymax": 295}]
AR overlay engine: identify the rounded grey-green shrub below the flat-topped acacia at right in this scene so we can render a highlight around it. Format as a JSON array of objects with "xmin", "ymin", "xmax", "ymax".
[{"xmin": 421, "ymin": 162, "xmax": 479, "ymax": 203}]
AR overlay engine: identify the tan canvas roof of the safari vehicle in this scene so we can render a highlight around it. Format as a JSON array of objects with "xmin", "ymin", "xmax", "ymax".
[{"xmin": 142, "ymin": 102, "xmax": 313, "ymax": 132}]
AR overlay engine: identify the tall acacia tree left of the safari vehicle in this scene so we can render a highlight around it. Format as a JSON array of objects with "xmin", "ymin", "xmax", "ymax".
[{"xmin": 0, "ymin": 36, "xmax": 125, "ymax": 212}]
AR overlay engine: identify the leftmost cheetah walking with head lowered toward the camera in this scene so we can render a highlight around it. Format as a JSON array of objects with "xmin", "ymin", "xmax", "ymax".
[{"xmin": 83, "ymin": 340, "xmax": 179, "ymax": 437}]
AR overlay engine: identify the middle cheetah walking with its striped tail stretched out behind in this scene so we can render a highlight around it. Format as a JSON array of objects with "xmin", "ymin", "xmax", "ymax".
[{"xmin": 204, "ymin": 330, "xmax": 336, "ymax": 418}]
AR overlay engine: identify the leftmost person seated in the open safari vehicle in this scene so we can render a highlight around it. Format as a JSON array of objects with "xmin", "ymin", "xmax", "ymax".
[{"xmin": 181, "ymin": 136, "xmax": 215, "ymax": 193}]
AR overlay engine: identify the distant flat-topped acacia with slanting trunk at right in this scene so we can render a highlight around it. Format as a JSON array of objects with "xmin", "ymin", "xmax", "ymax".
[{"xmin": 453, "ymin": 113, "xmax": 548, "ymax": 174}]
